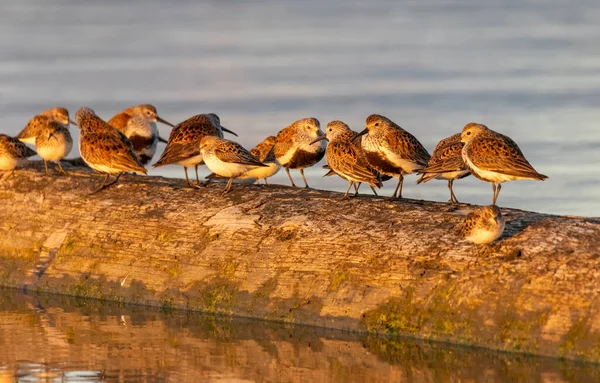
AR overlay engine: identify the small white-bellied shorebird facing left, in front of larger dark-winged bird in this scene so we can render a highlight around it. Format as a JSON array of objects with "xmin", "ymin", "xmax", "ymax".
[{"xmin": 200, "ymin": 136, "xmax": 269, "ymax": 193}]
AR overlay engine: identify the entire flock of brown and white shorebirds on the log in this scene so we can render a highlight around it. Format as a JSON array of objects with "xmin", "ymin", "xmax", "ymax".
[{"xmin": 0, "ymin": 104, "xmax": 547, "ymax": 243}]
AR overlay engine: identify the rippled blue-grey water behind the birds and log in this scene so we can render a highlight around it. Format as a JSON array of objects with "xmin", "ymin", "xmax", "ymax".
[{"xmin": 0, "ymin": 0, "xmax": 600, "ymax": 216}]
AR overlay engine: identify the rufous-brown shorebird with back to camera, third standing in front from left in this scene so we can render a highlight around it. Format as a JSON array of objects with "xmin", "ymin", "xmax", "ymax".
[{"xmin": 75, "ymin": 107, "xmax": 147, "ymax": 193}]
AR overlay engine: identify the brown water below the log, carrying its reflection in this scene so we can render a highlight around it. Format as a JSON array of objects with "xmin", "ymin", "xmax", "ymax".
[{"xmin": 0, "ymin": 289, "xmax": 600, "ymax": 383}]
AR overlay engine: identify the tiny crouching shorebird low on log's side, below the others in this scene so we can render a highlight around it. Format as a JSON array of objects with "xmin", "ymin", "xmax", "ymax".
[{"xmin": 459, "ymin": 205, "xmax": 504, "ymax": 244}]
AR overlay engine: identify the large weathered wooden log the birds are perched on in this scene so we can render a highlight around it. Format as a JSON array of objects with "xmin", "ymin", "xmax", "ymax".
[{"xmin": 0, "ymin": 164, "xmax": 600, "ymax": 361}]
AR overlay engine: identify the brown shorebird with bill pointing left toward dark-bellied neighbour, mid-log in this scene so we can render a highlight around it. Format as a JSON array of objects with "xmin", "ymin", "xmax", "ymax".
[{"xmin": 313, "ymin": 120, "xmax": 383, "ymax": 199}]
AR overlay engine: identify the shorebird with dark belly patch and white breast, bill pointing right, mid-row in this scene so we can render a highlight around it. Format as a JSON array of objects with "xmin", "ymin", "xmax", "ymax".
[{"xmin": 273, "ymin": 117, "xmax": 327, "ymax": 187}]
